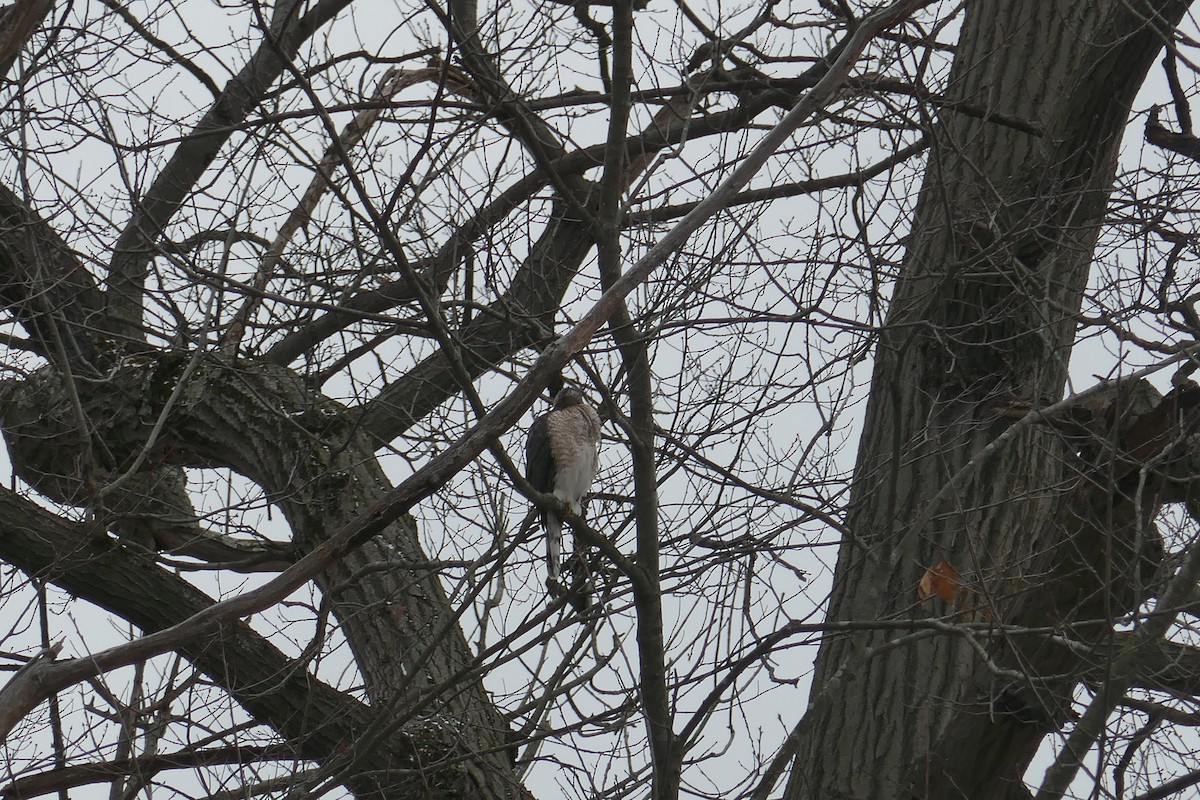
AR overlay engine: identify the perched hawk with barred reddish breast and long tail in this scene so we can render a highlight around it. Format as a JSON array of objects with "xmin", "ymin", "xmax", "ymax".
[{"xmin": 526, "ymin": 389, "xmax": 600, "ymax": 595}]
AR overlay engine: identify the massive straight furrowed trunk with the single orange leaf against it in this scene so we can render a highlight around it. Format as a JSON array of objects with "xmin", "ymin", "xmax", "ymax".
[{"xmin": 785, "ymin": 0, "xmax": 1187, "ymax": 800}]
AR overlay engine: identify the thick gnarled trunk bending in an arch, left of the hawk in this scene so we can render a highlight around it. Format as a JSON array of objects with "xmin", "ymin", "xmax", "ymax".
[{"xmin": 2, "ymin": 362, "xmax": 527, "ymax": 799}]
